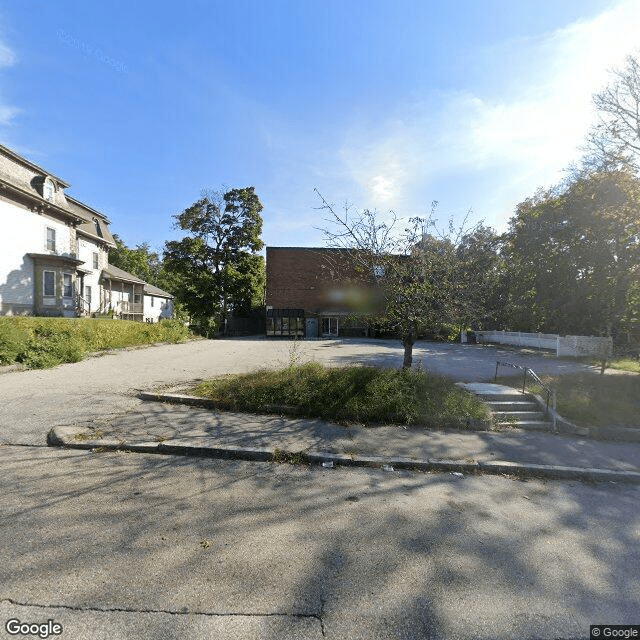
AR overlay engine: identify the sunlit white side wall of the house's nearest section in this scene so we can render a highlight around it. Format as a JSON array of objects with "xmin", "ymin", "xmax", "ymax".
[{"xmin": 0, "ymin": 200, "xmax": 73, "ymax": 306}]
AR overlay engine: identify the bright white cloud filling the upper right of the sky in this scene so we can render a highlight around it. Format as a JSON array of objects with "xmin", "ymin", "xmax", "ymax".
[{"xmin": 339, "ymin": 0, "xmax": 640, "ymax": 225}]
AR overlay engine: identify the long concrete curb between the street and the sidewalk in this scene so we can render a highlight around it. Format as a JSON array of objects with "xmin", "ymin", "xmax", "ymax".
[{"xmin": 47, "ymin": 427, "xmax": 640, "ymax": 484}]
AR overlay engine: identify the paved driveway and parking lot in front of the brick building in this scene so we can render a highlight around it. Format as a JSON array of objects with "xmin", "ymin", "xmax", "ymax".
[{"xmin": 0, "ymin": 338, "xmax": 588, "ymax": 444}]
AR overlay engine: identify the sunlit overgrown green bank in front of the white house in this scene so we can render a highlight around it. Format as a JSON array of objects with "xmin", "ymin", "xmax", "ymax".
[{"xmin": 0, "ymin": 317, "xmax": 189, "ymax": 369}]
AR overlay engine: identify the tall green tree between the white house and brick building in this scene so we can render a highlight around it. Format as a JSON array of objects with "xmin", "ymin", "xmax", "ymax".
[{"xmin": 164, "ymin": 187, "xmax": 264, "ymax": 327}]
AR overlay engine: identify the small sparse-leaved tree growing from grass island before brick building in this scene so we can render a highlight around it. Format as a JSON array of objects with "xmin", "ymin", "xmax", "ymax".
[{"xmin": 316, "ymin": 190, "xmax": 480, "ymax": 368}]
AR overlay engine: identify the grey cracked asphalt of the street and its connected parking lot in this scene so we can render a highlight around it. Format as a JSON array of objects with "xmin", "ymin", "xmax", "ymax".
[{"xmin": 0, "ymin": 340, "xmax": 640, "ymax": 640}]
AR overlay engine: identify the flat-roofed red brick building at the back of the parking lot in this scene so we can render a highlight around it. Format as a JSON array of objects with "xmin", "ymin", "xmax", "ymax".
[{"xmin": 266, "ymin": 247, "xmax": 379, "ymax": 338}]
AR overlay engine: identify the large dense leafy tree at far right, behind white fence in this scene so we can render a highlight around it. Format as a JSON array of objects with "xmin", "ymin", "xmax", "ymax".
[{"xmin": 505, "ymin": 171, "xmax": 640, "ymax": 335}]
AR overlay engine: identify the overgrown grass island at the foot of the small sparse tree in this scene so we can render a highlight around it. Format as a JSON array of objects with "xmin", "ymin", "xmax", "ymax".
[{"xmin": 190, "ymin": 363, "xmax": 489, "ymax": 427}]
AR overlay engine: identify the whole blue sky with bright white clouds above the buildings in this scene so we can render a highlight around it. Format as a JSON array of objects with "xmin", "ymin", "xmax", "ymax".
[{"xmin": 0, "ymin": 0, "xmax": 640, "ymax": 252}]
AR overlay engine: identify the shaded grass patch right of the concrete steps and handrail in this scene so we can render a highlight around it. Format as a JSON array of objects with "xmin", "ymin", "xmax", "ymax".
[{"xmin": 498, "ymin": 372, "xmax": 640, "ymax": 427}]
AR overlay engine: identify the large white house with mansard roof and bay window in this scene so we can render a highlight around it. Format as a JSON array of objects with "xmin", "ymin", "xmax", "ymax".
[{"xmin": 0, "ymin": 145, "xmax": 173, "ymax": 322}]
